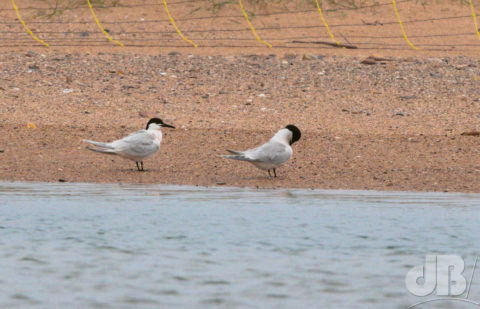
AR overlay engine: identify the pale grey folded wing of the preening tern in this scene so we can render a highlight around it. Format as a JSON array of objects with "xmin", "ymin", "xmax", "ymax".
[{"xmin": 244, "ymin": 140, "xmax": 292, "ymax": 164}]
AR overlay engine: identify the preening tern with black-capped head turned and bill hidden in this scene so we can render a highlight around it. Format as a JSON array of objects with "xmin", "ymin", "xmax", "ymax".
[{"xmin": 221, "ymin": 124, "xmax": 302, "ymax": 177}]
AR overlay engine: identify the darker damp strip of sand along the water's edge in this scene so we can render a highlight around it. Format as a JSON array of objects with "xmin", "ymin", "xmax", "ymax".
[{"xmin": 0, "ymin": 126, "xmax": 480, "ymax": 192}]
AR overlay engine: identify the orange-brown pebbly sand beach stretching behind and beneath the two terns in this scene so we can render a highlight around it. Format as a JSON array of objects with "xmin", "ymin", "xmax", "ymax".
[{"xmin": 0, "ymin": 1, "xmax": 480, "ymax": 192}]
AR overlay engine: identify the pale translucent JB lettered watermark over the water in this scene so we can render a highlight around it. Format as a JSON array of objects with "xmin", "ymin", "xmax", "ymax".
[{"xmin": 405, "ymin": 255, "xmax": 480, "ymax": 308}]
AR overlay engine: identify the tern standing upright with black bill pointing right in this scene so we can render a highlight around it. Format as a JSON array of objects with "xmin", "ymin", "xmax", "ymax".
[{"xmin": 83, "ymin": 118, "xmax": 175, "ymax": 171}]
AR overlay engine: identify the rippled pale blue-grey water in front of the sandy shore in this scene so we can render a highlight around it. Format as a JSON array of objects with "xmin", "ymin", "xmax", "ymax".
[{"xmin": 0, "ymin": 183, "xmax": 480, "ymax": 308}]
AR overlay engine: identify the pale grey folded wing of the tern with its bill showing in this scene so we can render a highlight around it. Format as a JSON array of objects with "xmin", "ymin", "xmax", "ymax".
[{"xmin": 111, "ymin": 130, "xmax": 159, "ymax": 156}]
